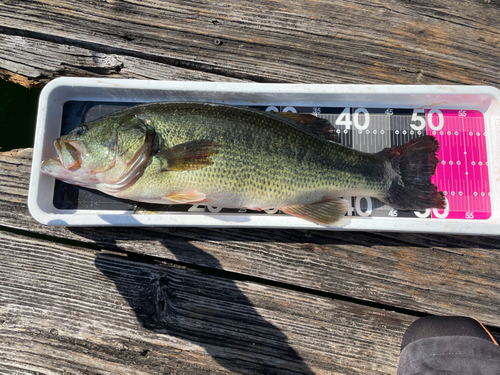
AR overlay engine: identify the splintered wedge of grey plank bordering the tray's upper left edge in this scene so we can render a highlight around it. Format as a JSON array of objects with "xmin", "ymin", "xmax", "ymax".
[{"xmin": 0, "ymin": 34, "xmax": 248, "ymax": 86}]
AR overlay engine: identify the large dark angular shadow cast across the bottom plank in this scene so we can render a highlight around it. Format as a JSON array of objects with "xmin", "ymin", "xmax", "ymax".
[{"xmin": 95, "ymin": 246, "xmax": 313, "ymax": 374}]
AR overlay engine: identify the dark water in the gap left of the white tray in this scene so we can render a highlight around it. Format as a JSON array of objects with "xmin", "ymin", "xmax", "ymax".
[{"xmin": 0, "ymin": 79, "xmax": 41, "ymax": 151}]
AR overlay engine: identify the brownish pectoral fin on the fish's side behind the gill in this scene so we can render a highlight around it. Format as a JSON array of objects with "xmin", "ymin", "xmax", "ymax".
[{"xmin": 156, "ymin": 139, "xmax": 218, "ymax": 171}]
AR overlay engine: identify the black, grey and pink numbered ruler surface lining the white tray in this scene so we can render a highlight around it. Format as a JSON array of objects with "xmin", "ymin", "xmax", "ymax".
[{"xmin": 54, "ymin": 101, "xmax": 491, "ymax": 220}]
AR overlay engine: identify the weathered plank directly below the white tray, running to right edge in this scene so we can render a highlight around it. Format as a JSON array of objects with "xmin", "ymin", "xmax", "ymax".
[{"xmin": 0, "ymin": 150, "xmax": 500, "ymax": 327}]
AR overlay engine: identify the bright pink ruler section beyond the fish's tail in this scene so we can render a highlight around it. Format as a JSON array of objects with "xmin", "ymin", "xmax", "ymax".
[{"xmin": 426, "ymin": 109, "xmax": 491, "ymax": 220}]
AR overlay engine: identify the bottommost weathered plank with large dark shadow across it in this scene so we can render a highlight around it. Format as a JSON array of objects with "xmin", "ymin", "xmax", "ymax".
[{"xmin": 0, "ymin": 231, "xmax": 415, "ymax": 374}]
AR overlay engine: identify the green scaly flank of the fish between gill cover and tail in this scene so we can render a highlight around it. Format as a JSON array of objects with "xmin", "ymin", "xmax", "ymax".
[{"xmin": 127, "ymin": 104, "xmax": 385, "ymax": 209}]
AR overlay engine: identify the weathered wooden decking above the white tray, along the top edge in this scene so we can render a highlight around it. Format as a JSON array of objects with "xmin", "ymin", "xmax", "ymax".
[{"xmin": 0, "ymin": 0, "xmax": 500, "ymax": 85}]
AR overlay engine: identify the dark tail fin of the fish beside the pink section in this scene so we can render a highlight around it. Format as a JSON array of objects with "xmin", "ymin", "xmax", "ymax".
[{"xmin": 381, "ymin": 135, "xmax": 446, "ymax": 210}]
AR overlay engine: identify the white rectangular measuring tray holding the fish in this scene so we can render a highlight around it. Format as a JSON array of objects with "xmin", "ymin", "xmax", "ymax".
[{"xmin": 28, "ymin": 78, "xmax": 500, "ymax": 235}]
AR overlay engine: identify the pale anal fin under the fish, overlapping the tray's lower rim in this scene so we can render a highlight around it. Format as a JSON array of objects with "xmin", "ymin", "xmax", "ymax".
[{"xmin": 280, "ymin": 198, "xmax": 347, "ymax": 225}]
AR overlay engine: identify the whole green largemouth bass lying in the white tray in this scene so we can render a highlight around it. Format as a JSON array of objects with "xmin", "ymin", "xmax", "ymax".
[{"xmin": 42, "ymin": 102, "xmax": 445, "ymax": 224}]
